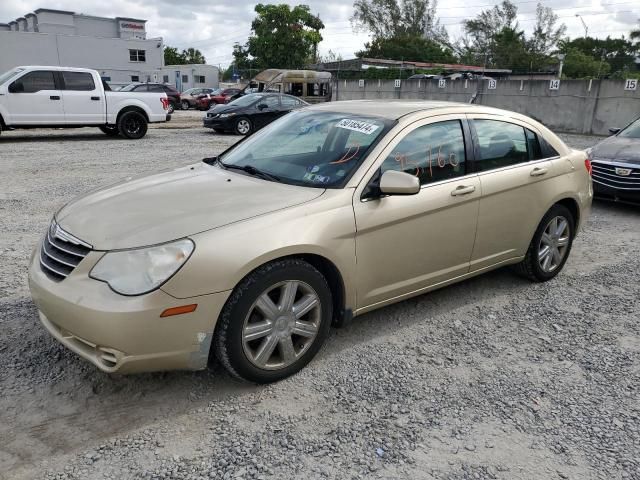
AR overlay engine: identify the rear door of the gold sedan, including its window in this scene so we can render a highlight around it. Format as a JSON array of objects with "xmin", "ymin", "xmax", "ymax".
[{"xmin": 469, "ymin": 115, "xmax": 563, "ymax": 271}]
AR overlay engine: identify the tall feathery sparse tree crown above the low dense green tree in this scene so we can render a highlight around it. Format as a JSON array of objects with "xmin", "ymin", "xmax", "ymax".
[{"xmin": 351, "ymin": 0, "xmax": 449, "ymax": 44}]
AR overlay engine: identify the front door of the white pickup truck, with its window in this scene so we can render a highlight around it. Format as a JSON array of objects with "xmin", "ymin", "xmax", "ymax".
[{"xmin": 7, "ymin": 70, "xmax": 65, "ymax": 125}]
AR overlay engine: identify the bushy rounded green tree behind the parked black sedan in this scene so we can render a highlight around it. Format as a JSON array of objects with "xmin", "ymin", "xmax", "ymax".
[{"xmin": 241, "ymin": 4, "xmax": 324, "ymax": 69}]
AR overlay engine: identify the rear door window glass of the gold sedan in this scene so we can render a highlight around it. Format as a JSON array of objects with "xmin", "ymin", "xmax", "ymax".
[{"xmin": 473, "ymin": 120, "xmax": 529, "ymax": 172}]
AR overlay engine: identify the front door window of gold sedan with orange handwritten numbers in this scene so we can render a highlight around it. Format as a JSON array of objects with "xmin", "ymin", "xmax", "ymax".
[{"xmin": 381, "ymin": 120, "xmax": 466, "ymax": 185}]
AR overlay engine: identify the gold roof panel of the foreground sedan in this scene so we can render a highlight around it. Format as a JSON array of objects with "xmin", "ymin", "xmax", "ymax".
[{"xmin": 308, "ymin": 100, "xmax": 519, "ymax": 120}]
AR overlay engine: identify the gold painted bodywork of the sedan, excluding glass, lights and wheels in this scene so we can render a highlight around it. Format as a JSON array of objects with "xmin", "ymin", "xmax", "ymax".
[{"xmin": 29, "ymin": 101, "xmax": 592, "ymax": 372}]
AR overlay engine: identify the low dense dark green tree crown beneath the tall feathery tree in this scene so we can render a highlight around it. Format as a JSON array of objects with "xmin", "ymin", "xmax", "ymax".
[{"xmin": 356, "ymin": 34, "xmax": 456, "ymax": 63}]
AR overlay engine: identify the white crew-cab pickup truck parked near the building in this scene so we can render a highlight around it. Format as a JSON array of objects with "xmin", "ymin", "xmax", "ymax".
[{"xmin": 0, "ymin": 67, "xmax": 171, "ymax": 139}]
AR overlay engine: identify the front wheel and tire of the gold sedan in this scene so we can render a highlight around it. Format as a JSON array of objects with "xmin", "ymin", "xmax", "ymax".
[{"xmin": 212, "ymin": 259, "xmax": 333, "ymax": 384}]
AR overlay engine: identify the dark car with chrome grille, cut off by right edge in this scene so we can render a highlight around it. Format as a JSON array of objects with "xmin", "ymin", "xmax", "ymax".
[{"xmin": 588, "ymin": 118, "xmax": 640, "ymax": 204}]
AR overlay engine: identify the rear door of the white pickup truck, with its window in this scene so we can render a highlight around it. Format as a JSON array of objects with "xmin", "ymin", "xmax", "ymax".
[{"xmin": 60, "ymin": 71, "xmax": 106, "ymax": 125}]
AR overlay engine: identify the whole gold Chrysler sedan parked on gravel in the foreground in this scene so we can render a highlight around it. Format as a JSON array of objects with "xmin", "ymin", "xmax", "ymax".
[{"xmin": 29, "ymin": 101, "xmax": 592, "ymax": 383}]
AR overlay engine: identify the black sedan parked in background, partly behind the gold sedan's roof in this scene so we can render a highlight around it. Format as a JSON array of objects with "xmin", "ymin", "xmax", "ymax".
[{"xmin": 203, "ymin": 93, "xmax": 308, "ymax": 135}]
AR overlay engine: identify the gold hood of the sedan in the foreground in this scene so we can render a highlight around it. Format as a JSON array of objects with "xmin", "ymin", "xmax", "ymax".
[{"xmin": 56, "ymin": 163, "xmax": 324, "ymax": 250}]
